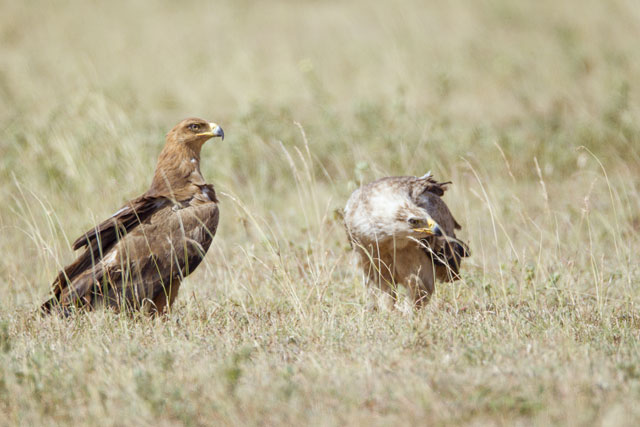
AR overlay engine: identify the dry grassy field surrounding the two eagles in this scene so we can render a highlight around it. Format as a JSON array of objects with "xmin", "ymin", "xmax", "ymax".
[{"xmin": 0, "ymin": 0, "xmax": 640, "ymax": 425}]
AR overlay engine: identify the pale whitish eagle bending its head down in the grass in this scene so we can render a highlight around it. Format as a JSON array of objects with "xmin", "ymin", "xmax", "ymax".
[{"xmin": 344, "ymin": 172, "xmax": 469, "ymax": 308}]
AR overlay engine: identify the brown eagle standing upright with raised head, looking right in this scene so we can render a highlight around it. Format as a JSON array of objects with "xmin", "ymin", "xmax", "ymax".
[{"xmin": 41, "ymin": 118, "xmax": 224, "ymax": 314}]
